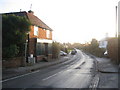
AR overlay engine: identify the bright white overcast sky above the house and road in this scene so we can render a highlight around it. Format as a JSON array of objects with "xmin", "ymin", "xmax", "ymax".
[{"xmin": 0, "ymin": 0, "xmax": 119, "ymax": 43}]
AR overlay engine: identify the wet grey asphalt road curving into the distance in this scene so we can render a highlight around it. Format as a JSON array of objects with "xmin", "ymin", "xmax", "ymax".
[{"xmin": 2, "ymin": 50, "xmax": 94, "ymax": 90}]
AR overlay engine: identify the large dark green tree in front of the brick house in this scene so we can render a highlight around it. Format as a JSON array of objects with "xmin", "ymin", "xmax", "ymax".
[{"xmin": 2, "ymin": 15, "xmax": 30, "ymax": 58}]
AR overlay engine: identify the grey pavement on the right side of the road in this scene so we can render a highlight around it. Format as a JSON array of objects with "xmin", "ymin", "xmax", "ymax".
[{"xmin": 95, "ymin": 57, "xmax": 119, "ymax": 88}]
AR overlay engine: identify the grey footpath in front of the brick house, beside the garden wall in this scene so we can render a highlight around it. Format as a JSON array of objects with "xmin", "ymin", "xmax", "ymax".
[{"xmin": 2, "ymin": 54, "xmax": 73, "ymax": 80}]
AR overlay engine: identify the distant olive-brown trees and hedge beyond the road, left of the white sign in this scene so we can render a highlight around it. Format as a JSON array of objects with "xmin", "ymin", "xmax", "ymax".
[{"xmin": 63, "ymin": 39, "xmax": 105, "ymax": 57}]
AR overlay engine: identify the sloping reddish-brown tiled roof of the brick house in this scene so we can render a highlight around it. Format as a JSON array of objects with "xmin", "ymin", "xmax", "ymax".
[{"xmin": 2, "ymin": 11, "xmax": 52, "ymax": 31}]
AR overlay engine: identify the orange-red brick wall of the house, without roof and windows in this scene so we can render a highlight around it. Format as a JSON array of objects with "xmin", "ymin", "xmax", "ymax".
[{"xmin": 28, "ymin": 26, "xmax": 52, "ymax": 62}]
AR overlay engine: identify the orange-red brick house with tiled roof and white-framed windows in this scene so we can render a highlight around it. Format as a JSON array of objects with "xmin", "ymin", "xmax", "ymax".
[{"xmin": 6, "ymin": 10, "xmax": 53, "ymax": 62}]
